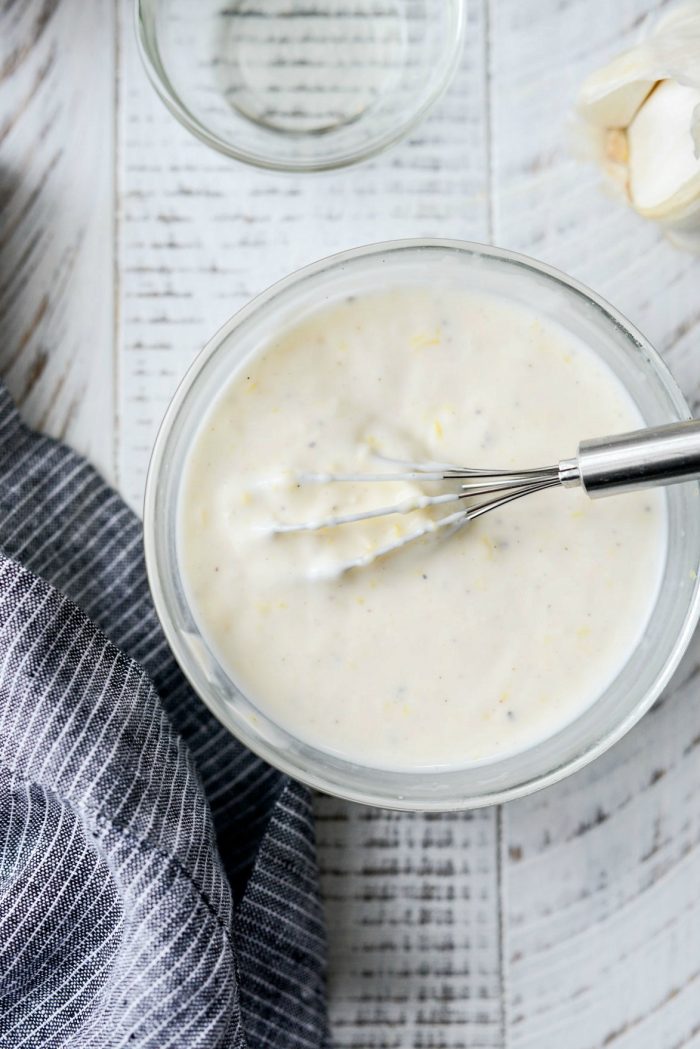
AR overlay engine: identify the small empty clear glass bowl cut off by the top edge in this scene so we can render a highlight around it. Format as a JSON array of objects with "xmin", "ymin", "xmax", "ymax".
[{"xmin": 136, "ymin": 0, "xmax": 465, "ymax": 171}]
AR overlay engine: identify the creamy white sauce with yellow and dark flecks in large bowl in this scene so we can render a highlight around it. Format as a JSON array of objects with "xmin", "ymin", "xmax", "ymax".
[{"xmin": 178, "ymin": 287, "xmax": 665, "ymax": 769}]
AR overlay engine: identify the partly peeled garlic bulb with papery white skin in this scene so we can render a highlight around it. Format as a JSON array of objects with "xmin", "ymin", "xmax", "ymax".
[{"xmin": 578, "ymin": 0, "xmax": 700, "ymax": 253}]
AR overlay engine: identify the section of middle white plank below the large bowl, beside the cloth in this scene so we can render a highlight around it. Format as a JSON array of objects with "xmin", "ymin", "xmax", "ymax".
[{"xmin": 316, "ymin": 796, "xmax": 503, "ymax": 1049}]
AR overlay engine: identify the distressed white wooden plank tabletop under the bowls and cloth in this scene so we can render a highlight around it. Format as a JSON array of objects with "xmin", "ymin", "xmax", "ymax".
[{"xmin": 0, "ymin": 0, "xmax": 700, "ymax": 1049}]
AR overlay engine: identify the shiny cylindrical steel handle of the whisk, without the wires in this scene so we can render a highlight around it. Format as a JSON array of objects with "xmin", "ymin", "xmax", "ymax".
[{"xmin": 559, "ymin": 420, "xmax": 700, "ymax": 498}]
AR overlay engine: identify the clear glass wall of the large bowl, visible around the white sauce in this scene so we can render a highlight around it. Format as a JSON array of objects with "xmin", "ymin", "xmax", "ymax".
[{"xmin": 144, "ymin": 240, "xmax": 700, "ymax": 810}]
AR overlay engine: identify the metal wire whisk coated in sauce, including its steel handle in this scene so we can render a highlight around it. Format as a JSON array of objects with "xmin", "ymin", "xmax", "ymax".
[{"xmin": 271, "ymin": 420, "xmax": 700, "ymax": 572}]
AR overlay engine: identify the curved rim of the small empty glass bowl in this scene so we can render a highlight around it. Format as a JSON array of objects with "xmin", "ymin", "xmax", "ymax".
[{"xmin": 133, "ymin": 0, "xmax": 467, "ymax": 173}]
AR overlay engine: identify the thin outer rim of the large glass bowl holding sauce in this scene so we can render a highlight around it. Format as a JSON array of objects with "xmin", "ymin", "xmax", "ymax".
[{"xmin": 144, "ymin": 238, "xmax": 700, "ymax": 812}]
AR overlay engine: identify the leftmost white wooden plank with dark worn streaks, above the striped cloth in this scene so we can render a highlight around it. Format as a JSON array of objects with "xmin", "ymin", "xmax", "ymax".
[{"xmin": 0, "ymin": 0, "xmax": 114, "ymax": 477}]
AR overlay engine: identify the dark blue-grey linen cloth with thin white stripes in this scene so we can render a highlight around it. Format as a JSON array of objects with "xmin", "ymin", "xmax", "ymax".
[{"xmin": 0, "ymin": 385, "xmax": 328, "ymax": 1049}]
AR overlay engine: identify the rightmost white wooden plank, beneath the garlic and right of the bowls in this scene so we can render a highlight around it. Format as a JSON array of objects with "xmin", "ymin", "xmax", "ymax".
[{"xmin": 490, "ymin": 0, "xmax": 700, "ymax": 1049}]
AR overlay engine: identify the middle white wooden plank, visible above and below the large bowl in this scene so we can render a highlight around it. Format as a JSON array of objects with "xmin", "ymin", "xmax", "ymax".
[{"xmin": 119, "ymin": 4, "xmax": 502, "ymax": 1049}]
